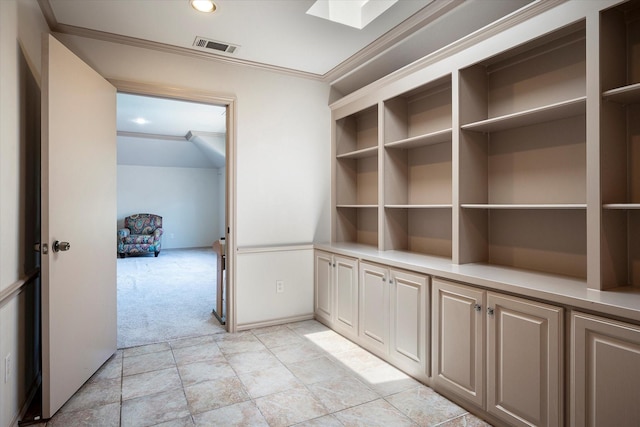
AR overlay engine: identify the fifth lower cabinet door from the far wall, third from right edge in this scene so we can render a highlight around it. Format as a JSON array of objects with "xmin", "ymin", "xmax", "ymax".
[{"xmin": 432, "ymin": 279, "xmax": 485, "ymax": 408}]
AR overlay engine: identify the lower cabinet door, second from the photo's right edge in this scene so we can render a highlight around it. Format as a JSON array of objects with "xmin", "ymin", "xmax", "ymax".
[{"xmin": 487, "ymin": 293, "xmax": 564, "ymax": 426}]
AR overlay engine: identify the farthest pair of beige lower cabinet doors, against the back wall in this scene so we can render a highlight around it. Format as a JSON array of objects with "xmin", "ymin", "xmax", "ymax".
[{"xmin": 314, "ymin": 251, "xmax": 358, "ymax": 338}]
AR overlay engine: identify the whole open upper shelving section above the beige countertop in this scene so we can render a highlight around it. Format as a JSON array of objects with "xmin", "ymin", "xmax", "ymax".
[{"xmin": 332, "ymin": 0, "xmax": 640, "ymax": 290}]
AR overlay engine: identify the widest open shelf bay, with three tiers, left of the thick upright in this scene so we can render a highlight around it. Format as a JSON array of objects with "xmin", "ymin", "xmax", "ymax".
[{"xmin": 458, "ymin": 23, "xmax": 587, "ymax": 279}]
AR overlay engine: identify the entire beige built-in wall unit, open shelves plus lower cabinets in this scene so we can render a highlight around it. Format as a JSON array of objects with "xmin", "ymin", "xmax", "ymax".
[{"xmin": 318, "ymin": 0, "xmax": 640, "ymax": 425}]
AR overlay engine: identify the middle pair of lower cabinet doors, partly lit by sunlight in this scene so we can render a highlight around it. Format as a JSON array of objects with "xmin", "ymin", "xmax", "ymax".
[{"xmin": 358, "ymin": 262, "xmax": 429, "ymax": 380}]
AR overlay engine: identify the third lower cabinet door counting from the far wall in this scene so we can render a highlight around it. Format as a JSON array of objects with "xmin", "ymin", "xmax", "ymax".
[{"xmin": 358, "ymin": 263, "xmax": 389, "ymax": 355}]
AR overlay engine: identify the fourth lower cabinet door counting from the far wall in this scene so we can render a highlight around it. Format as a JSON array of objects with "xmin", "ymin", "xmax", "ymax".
[{"xmin": 389, "ymin": 270, "xmax": 429, "ymax": 379}]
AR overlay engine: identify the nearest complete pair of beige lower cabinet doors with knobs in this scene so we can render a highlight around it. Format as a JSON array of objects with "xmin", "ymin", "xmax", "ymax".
[{"xmin": 432, "ymin": 279, "xmax": 563, "ymax": 426}]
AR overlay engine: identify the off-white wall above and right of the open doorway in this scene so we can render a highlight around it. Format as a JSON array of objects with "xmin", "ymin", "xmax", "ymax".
[{"xmin": 59, "ymin": 36, "xmax": 331, "ymax": 324}]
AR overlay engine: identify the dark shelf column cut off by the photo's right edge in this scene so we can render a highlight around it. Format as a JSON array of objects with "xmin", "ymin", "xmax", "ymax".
[{"xmin": 600, "ymin": 1, "xmax": 640, "ymax": 289}]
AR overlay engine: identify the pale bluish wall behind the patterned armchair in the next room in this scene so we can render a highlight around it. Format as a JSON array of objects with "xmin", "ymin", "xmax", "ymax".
[{"xmin": 118, "ymin": 165, "xmax": 224, "ymax": 249}]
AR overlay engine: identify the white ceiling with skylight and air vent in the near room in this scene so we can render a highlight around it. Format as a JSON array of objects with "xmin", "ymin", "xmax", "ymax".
[{"xmin": 39, "ymin": 0, "xmax": 535, "ymax": 94}]
